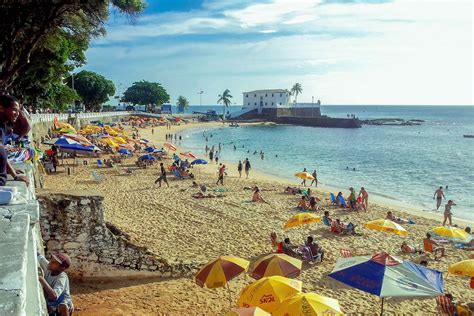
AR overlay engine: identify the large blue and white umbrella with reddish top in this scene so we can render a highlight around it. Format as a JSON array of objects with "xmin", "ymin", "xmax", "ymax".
[{"xmin": 329, "ymin": 252, "xmax": 444, "ymax": 311}]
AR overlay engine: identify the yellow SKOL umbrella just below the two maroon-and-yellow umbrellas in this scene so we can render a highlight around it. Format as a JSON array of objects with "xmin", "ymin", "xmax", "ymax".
[{"xmin": 238, "ymin": 276, "xmax": 303, "ymax": 313}]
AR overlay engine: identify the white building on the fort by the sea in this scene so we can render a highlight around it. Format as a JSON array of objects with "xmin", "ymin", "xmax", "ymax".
[{"xmin": 243, "ymin": 89, "xmax": 290, "ymax": 109}]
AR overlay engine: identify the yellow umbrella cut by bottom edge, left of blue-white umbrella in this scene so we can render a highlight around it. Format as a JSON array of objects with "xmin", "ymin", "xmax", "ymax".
[{"xmin": 272, "ymin": 293, "xmax": 343, "ymax": 316}]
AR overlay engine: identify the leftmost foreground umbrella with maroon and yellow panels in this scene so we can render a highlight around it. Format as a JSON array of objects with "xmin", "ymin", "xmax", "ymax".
[{"xmin": 196, "ymin": 256, "xmax": 250, "ymax": 289}]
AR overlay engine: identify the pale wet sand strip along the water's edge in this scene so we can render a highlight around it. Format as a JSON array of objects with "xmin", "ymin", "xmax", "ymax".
[{"xmin": 168, "ymin": 122, "xmax": 474, "ymax": 226}]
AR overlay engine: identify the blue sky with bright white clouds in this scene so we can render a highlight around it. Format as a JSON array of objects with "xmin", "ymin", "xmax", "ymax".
[{"xmin": 84, "ymin": 0, "xmax": 473, "ymax": 105}]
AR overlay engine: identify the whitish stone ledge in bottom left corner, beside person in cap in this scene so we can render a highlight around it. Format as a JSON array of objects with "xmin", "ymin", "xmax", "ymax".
[{"xmin": 0, "ymin": 209, "xmax": 30, "ymax": 316}]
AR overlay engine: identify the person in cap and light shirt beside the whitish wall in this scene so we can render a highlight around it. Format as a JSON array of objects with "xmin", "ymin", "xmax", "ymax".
[{"xmin": 38, "ymin": 253, "xmax": 73, "ymax": 316}]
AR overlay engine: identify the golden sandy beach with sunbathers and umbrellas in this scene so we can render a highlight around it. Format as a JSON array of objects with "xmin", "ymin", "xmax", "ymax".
[{"xmin": 39, "ymin": 123, "xmax": 474, "ymax": 315}]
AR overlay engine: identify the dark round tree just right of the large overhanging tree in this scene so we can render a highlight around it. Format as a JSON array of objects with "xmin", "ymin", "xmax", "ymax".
[{"xmin": 67, "ymin": 70, "xmax": 115, "ymax": 110}]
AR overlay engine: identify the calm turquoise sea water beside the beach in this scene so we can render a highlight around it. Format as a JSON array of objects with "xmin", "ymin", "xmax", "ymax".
[{"xmin": 182, "ymin": 106, "xmax": 474, "ymax": 220}]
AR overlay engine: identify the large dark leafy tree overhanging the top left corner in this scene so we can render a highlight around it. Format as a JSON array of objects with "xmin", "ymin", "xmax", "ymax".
[{"xmin": 0, "ymin": 0, "xmax": 145, "ymax": 107}]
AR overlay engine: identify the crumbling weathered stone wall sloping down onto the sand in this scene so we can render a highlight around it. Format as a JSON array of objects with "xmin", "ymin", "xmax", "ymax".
[{"xmin": 38, "ymin": 191, "xmax": 197, "ymax": 279}]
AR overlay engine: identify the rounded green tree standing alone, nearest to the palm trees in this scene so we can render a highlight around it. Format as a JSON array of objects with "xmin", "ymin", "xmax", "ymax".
[{"xmin": 122, "ymin": 80, "xmax": 170, "ymax": 106}]
